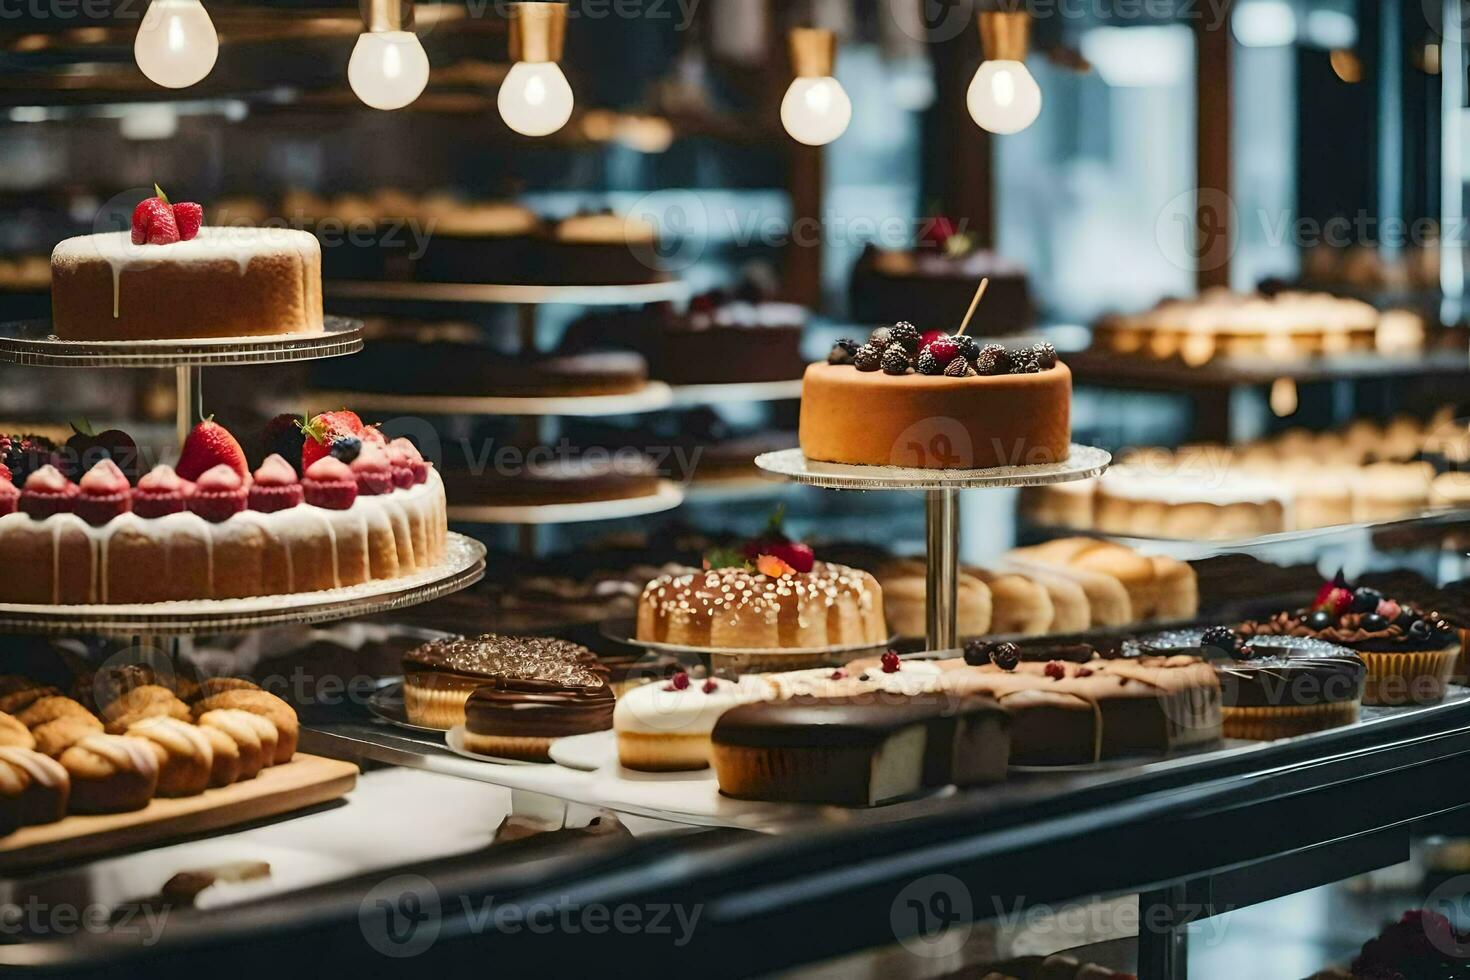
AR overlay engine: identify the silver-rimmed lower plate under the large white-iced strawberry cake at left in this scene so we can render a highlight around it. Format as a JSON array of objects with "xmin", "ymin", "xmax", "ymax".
[{"xmin": 0, "ymin": 533, "xmax": 485, "ymax": 638}]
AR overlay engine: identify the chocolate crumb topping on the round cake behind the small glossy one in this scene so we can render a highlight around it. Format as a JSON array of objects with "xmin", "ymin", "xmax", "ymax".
[{"xmin": 403, "ymin": 633, "xmax": 607, "ymax": 686}]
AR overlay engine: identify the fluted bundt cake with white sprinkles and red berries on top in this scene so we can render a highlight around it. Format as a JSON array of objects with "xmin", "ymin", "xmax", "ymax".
[{"xmin": 638, "ymin": 514, "xmax": 888, "ymax": 649}]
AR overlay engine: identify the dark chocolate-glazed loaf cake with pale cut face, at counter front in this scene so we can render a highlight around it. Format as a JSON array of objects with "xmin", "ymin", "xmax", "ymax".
[{"xmin": 711, "ymin": 693, "xmax": 1010, "ymax": 807}]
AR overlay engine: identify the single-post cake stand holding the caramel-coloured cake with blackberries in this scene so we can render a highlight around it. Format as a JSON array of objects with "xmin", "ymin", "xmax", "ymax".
[{"xmin": 756, "ymin": 445, "xmax": 1113, "ymax": 649}]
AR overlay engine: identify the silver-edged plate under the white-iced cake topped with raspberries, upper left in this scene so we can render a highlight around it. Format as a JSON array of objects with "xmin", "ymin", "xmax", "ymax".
[{"xmin": 0, "ymin": 316, "xmax": 363, "ymax": 367}]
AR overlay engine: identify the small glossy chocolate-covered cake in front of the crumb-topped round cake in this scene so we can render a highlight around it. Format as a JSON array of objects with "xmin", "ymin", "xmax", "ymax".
[{"xmin": 465, "ymin": 674, "xmax": 613, "ymax": 763}]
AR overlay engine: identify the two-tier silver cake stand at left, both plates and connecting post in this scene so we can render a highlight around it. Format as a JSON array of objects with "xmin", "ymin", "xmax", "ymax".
[{"xmin": 0, "ymin": 317, "xmax": 485, "ymax": 642}]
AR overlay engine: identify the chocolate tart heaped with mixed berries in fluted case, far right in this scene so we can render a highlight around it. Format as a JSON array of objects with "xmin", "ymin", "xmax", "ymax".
[{"xmin": 1239, "ymin": 573, "xmax": 1461, "ymax": 705}]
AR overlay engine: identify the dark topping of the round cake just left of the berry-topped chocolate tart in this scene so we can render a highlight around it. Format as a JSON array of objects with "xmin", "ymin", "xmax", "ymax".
[{"xmin": 1144, "ymin": 630, "xmax": 1367, "ymax": 708}]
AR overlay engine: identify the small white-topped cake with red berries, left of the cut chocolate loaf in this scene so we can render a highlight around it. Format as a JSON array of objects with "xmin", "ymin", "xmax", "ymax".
[{"xmin": 613, "ymin": 673, "xmax": 776, "ymax": 773}]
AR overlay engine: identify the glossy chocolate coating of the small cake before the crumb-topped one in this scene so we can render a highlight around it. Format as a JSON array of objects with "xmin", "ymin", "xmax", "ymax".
[{"xmin": 465, "ymin": 677, "xmax": 614, "ymax": 739}]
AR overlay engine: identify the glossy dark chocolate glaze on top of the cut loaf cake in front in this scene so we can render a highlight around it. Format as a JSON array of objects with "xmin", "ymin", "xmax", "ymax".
[{"xmin": 713, "ymin": 693, "xmax": 1005, "ymax": 748}]
